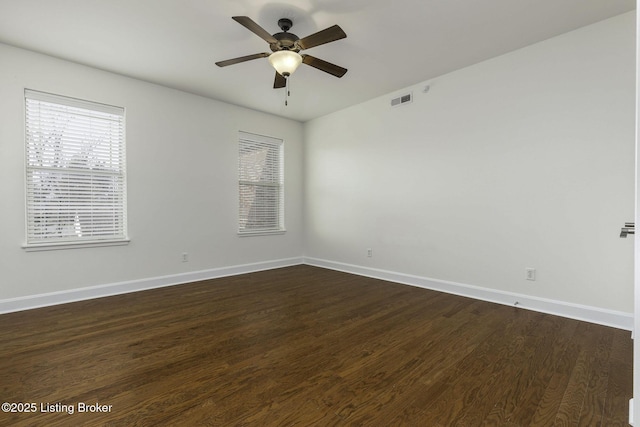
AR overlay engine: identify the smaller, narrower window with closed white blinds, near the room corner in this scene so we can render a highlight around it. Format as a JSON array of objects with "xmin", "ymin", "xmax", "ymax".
[{"xmin": 238, "ymin": 132, "xmax": 285, "ymax": 234}]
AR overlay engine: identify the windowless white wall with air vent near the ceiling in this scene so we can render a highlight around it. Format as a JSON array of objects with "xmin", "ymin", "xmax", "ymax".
[{"xmin": 305, "ymin": 12, "xmax": 635, "ymax": 313}]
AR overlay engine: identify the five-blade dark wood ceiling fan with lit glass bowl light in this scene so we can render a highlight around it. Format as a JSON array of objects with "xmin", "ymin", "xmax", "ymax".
[{"xmin": 216, "ymin": 16, "xmax": 347, "ymax": 89}]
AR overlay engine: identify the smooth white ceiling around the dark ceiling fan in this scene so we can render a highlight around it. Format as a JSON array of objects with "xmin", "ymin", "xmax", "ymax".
[{"xmin": 0, "ymin": 0, "xmax": 635, "ymax": 121}]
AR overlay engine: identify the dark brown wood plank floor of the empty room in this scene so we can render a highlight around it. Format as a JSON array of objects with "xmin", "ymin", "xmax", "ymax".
[{"xmin": 0, "ymin": 266, "xmax": 632, "ymax": 426}]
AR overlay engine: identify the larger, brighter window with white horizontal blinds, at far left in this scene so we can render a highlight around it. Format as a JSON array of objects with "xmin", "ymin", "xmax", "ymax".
[{"xmin": 25, "ymin": 89, "xmax": 127, "ymax": 249}]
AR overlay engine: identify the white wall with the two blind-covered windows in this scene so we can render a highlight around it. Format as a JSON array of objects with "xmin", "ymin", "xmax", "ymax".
[{"xmin": 0, "ymin": 45, "xmax": 303, "ymax": 301}]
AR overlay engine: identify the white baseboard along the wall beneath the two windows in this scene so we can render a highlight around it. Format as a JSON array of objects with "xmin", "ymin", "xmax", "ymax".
[{"xmin": 0, "ymin": 257, "xmax": 303, "ymax": 314}]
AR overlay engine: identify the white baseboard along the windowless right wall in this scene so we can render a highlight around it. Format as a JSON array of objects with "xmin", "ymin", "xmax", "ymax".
[{"xmin": 304, "ymin": 257, "xmax": 633, "ymax": 331}]
